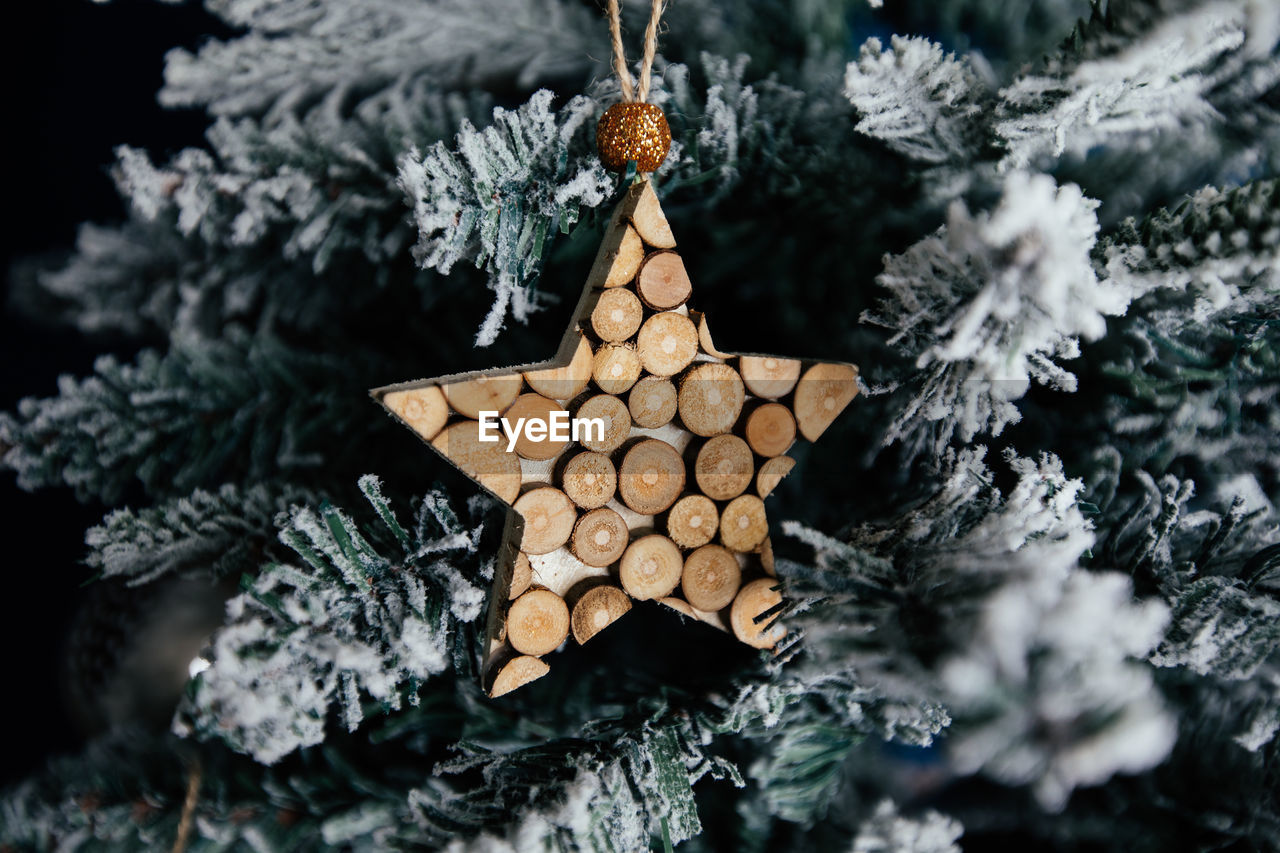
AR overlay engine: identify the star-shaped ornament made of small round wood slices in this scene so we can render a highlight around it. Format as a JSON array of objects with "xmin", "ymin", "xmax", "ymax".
[{"xmin": 372, "ymin": 181, "xmax": 858, "ymax": 697}]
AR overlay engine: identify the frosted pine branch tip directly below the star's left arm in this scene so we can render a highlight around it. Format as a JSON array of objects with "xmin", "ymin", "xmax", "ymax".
[{"xmin": 180, "ymin": 475, "xmax": 493, "ymax": 763}]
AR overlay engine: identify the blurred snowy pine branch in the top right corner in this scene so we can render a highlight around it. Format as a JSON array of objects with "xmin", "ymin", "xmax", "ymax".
[{"xmin": 993, "ymin": 0, "xmax": 1280, "ymax": 175}]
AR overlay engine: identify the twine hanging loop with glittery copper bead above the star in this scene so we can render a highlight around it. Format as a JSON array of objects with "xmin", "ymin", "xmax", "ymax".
[{"xmin": 595, "ymin": 0, "xmax": 671, "ymax": 173}]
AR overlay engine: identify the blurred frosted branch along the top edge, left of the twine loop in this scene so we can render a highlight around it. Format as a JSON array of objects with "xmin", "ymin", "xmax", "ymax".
[{"xmin": 160, "ymin": 0, "xmax": 604, "ymax": 123}]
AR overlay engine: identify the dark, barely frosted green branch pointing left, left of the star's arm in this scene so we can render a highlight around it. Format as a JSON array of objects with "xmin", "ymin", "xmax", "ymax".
[{"xmin": 0, "ymin": 329, "xmax": 383, "ymax": 503}]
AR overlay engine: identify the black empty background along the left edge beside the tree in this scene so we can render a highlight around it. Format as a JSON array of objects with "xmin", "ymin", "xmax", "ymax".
[{"xmin": 0, "ymin": 0, "xmax": 229, "ymax": 785}]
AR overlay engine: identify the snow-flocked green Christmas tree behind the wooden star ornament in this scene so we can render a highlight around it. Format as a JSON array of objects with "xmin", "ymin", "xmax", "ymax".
[{"xmin": 0, "ymin": 0, "xmax": 1280, "ymax": 853}]
